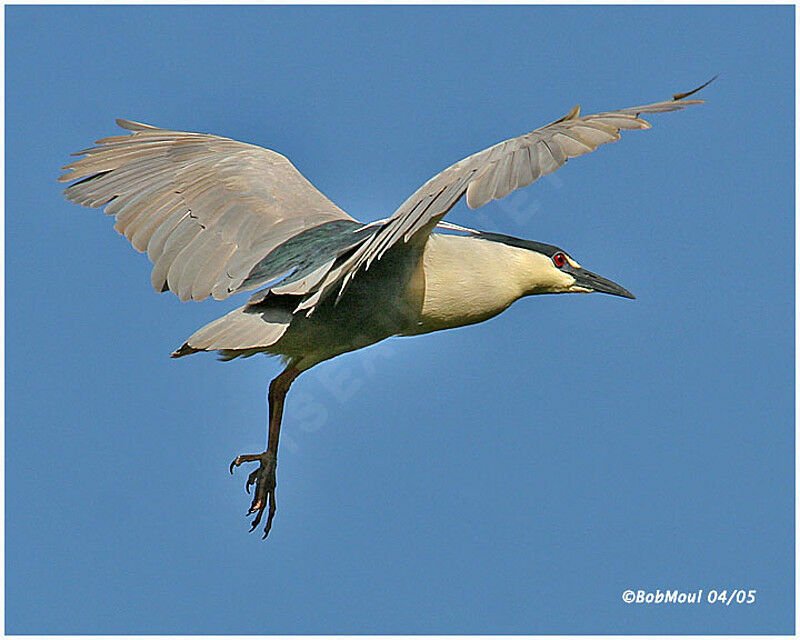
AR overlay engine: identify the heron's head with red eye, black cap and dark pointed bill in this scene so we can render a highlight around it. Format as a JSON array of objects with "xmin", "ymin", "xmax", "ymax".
[{"xmin": 482, "ymin": 233, "xmax": 636, "ymax": 298}]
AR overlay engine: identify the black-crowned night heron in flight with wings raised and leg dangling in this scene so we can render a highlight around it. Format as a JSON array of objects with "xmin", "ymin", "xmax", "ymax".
[{"xmin": 59, "ymin": 81, "xmax": 710, "ymax": 537}]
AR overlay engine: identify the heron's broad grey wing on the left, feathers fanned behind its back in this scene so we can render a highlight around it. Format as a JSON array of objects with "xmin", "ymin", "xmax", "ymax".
[{"xmin": 59, "ymin": 120, "xmax": 353, "ymax": 300}]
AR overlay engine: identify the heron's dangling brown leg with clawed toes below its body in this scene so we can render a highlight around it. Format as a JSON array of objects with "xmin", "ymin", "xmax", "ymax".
[{"xmin": 230, "ymin": 367, "xmax": 300, "ymax": 538}]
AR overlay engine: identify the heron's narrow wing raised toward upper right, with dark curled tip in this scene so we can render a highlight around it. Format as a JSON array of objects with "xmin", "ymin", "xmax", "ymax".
[{"xmin": 299, "ymin": 78, "xmax": 713, "ymax": 313}]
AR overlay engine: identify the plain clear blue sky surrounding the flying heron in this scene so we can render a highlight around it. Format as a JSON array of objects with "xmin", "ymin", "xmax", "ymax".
[{"xmin": 6, "ymin": 6, "xmax": 794, "ymax": 634}]
